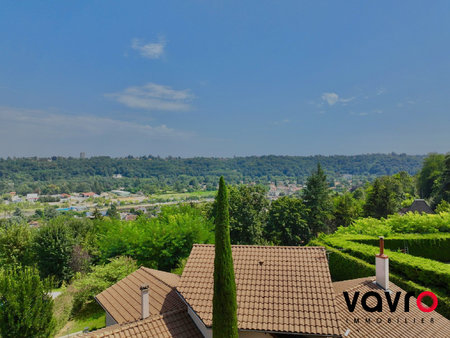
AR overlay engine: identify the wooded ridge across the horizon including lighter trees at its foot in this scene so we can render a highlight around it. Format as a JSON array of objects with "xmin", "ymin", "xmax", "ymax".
[{"xmin": 0, "ymin": 153, "xmax": 425, "ymax": 194}]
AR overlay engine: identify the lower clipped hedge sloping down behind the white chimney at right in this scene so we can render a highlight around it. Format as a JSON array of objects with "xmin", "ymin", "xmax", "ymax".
[{"xmin": 308, "ymin": 240, "xmax": 450, "ymax": 319}]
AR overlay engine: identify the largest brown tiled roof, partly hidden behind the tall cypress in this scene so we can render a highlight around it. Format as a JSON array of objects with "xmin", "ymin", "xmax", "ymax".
[{"xmin": 177, "ymin": 245, "xmax": 340, "ymax": 335}]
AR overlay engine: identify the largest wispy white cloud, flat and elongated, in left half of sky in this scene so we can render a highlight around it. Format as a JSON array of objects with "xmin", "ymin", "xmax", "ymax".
[{"xmin": 105, "ymin": 83, "xmax": 194, "ymax": 111}]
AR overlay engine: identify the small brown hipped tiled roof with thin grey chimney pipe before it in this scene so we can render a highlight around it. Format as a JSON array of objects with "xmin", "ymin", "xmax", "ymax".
[{"xmin": 95, "ymin": 267, "xmax": 186, "ymax": 324}]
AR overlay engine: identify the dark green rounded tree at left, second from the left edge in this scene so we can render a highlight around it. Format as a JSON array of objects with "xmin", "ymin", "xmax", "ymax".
[{"xmin": 34, "ymin": 222, "xmax": 75, "ymax": 283}]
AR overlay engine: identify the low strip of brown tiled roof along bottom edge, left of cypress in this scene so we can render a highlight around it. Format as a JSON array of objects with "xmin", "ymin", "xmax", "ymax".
[{"xmin": 84, "ymin": 310, "xmax": 203, "ymax": 338}]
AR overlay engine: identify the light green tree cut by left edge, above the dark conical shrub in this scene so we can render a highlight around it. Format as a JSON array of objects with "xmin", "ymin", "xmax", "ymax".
[{"xmin": 0, "ymin": 223, "xmax": 33, "ymax": 266}]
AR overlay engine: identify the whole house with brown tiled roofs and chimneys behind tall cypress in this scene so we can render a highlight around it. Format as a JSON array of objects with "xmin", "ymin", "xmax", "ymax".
[{"xmin": 88, "ymin": 244, "xmax": 450, "ymax": 338}]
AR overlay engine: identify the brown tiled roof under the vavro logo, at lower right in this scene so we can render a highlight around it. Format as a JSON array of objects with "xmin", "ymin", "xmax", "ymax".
[{"xmin": 333, "ymin": 277, "xmax": 450, "ymax": 338}]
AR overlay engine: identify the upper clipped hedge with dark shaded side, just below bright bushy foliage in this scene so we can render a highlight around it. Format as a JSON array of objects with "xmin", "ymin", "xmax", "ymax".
[{"xmin": 349, "ymin": 233, "xmax": 450, "ymax": 262}]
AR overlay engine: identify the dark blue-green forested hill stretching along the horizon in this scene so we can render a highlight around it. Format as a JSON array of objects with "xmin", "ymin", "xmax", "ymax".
[{"xmin": 0, "ymin": 154, "xmax": 425, "ymax": 183}]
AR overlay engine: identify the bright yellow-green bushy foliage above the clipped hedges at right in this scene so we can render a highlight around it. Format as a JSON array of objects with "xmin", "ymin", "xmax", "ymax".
[{"xmin": 336, "ymin": 212, "xmax": 450, "ymax": 236}]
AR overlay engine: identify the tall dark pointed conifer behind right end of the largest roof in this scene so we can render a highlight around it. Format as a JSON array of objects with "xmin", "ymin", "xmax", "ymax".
[{"xmin": 303, "ymin": 163, "xmax": 333, "ymax": 236}]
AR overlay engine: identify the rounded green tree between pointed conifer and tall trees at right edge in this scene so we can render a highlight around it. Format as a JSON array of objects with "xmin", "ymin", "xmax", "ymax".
[{"xmin": 364, "ymin": 176, "xmax": 402, "ymax": 218}]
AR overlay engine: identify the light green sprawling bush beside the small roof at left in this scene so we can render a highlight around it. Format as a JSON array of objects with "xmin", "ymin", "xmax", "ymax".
[{"xmin": 72, "ymin": 257, "xmax": 137, "ymax": 313}]
